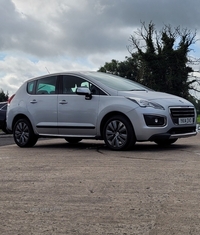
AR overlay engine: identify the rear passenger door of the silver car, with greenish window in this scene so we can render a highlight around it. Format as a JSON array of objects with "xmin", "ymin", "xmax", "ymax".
[{"xmin": 27, "ymin": 76, "xmax": 58, "ymax": 135}]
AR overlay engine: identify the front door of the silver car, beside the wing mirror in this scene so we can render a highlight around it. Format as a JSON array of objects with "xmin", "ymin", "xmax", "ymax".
[{"xmin": 58, "ymin": 75, "xmax": 99, "ymax": 137}]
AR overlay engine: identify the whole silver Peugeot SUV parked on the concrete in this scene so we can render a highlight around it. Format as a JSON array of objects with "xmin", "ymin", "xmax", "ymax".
[{"xmin": 7, "ymin": 72, "xmax": 197, "ymax": 150}]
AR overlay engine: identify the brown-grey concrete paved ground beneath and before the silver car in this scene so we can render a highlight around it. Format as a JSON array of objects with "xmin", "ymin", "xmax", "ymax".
[{"xmin": 0, "ymin": 134, "xmax": 200, "ymax": 235}]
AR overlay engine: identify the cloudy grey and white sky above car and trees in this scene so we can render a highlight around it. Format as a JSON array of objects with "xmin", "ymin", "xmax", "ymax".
[{"xmin": 0, "ymin": 0, "xmax": 200, "ymax": 96}]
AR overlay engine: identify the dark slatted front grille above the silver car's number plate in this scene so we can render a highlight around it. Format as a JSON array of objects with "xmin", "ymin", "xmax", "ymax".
[{"xmin": 170, "ymin": 107, "xmax": 195, "ymax": 125}]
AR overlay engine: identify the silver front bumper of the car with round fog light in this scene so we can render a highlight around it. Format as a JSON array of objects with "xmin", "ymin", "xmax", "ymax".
[{"xmin": 128, "ymin": 105, "xmax": 197, "ymax": 142}]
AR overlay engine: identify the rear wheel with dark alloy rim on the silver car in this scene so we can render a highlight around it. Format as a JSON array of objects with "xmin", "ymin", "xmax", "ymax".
[{"xmin": 13, "ymin": 119, "xmax": 38, "ymax": 148}]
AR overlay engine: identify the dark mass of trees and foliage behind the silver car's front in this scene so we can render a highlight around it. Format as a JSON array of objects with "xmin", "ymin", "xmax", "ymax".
[{"xmin": 99, "ymin": 22, "xmax": 198, "ymax": 99}]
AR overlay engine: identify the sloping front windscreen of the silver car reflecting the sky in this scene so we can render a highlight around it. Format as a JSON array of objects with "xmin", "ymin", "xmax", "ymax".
[{"xmin": 84, "ymin": 72, "xmax": 150, "ymax": 91}]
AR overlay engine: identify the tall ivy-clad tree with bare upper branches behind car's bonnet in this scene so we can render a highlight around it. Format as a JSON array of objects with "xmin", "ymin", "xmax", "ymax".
[{"xmin": 130, "ymin": 22, "xmax": 197, "ymax": 99}]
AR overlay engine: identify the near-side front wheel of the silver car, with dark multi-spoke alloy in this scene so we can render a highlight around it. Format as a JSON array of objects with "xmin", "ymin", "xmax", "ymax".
[{"xmin": 103, "ymin": 115, "xmax": 136, "ymax": 150}]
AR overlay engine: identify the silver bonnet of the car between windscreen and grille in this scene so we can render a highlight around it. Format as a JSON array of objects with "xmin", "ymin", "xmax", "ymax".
[{"xmin": 118, "ymin": 91, "xmax": 193, "ymax": 106}]
